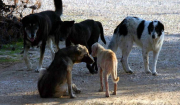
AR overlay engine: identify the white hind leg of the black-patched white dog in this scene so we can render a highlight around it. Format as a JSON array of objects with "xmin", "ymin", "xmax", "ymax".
[{"xmin": 120, "ymin": 38, "xmax": 133, "ymax": 74}]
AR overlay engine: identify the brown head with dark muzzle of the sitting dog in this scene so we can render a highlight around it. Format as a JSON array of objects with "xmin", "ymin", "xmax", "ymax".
[{"xmin": 75, "ymin": 44, "xmax": 94, "ymax": 64}]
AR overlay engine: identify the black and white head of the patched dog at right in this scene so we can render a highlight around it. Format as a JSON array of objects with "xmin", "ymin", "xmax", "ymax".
[{"xmin": 148, "ymin": 21, "xmax": 164, "ymax": 39}]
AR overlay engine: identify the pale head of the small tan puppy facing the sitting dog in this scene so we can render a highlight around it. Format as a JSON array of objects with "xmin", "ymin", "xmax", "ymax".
[{"xmin": 91, "ymin": 42, "xmax": 103, "ymax": 57}]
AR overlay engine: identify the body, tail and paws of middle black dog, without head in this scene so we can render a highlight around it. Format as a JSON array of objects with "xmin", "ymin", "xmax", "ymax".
[{"xmin": 66, "ymin": 20, "xmax": 106, "ymax": 74}]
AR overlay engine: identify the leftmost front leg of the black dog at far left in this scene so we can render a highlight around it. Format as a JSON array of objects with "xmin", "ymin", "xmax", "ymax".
[{"xmin": 23, "ymin": 45, "xmax": 32, "ymax": 70}]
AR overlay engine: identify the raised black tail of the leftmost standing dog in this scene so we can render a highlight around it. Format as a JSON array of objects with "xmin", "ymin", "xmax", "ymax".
[{"xmin": 54, "ymin": 0, "xmax": 63, "ymax": 16}]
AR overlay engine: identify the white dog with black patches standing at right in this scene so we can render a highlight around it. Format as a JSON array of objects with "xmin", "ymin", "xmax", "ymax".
[{"xmin": 108, "ymin": 16, "xmax": 164, "ymax": 75}]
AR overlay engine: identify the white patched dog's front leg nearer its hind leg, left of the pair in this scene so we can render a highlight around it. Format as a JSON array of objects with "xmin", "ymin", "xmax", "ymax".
[{"xmin": 142, "ymin": 49, "xmax": 151, "ymax": 74}]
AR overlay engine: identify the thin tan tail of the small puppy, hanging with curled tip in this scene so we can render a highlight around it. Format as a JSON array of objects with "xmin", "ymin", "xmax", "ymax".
[{"xmin": 111, "ymin": 59, "xmax": 119, "ymax": 83}]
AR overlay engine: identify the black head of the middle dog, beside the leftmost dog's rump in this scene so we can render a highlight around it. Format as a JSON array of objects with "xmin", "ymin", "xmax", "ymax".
[{"xmin": 56, "ymin": 21, "xmax": 74, "ymax": 41}]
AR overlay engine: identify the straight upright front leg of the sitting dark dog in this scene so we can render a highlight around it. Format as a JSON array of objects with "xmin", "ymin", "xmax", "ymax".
[{"xmin": 67, "ymin": 70, "xmax": 76, "ymax": 98}]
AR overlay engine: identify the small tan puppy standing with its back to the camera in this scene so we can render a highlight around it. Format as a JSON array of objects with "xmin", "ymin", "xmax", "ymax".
[{"xmin": 91, "ymin": 43, "xmax": 119, "ymax": 97}]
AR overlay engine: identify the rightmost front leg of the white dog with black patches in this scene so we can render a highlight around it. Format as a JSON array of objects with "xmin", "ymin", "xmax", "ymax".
[{"xmin": 152, "ymin": 51, "xmax": 159, "ymax": 76}]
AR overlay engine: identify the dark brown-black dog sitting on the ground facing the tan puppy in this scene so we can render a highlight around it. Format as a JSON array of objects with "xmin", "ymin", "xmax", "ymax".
[{"xmin": 38, "ymin": 44, "xmax": 94, "ymax": 98}]
